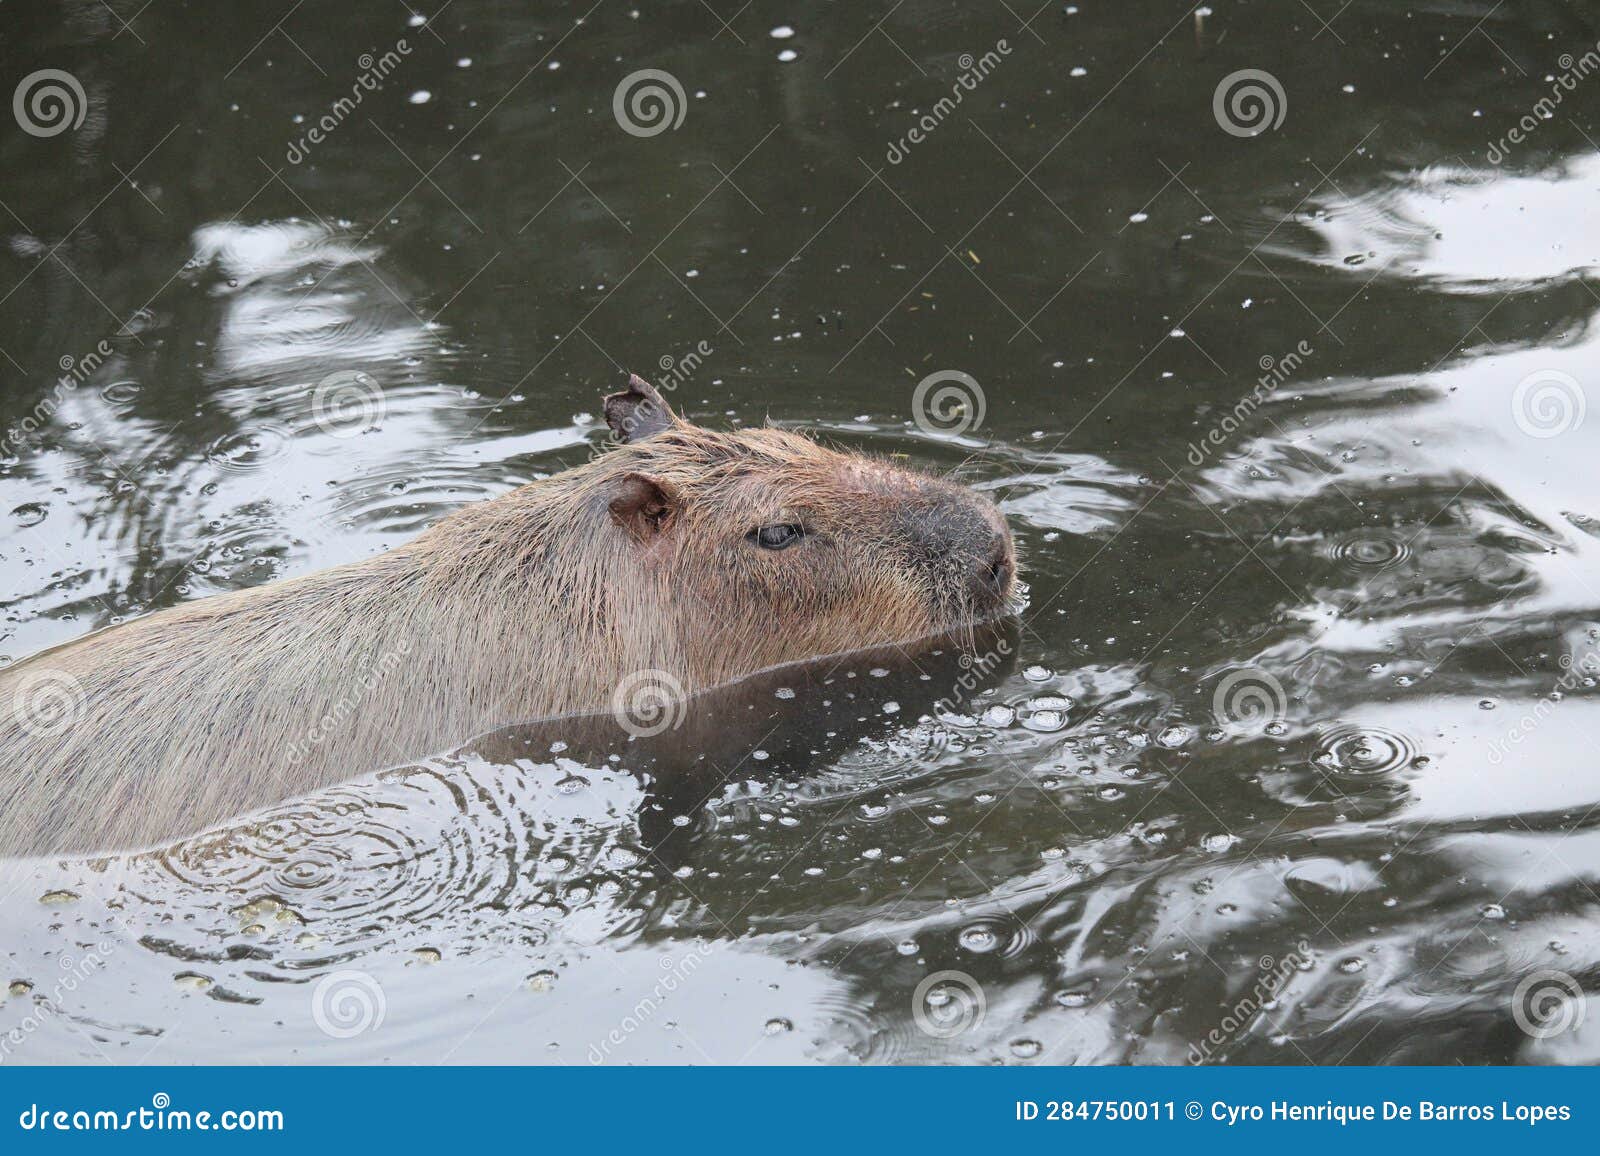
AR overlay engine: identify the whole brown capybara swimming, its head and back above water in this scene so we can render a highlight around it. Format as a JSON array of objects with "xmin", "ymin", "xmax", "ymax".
[{"xmin": 0, "ymin": 376, "xmax": 1016, "ymax": 855}]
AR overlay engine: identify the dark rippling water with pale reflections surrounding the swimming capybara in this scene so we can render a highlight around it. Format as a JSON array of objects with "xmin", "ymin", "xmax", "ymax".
[{"xmin": 0, "ymin": 0, "xmax": 1600, "ymax": 1063}]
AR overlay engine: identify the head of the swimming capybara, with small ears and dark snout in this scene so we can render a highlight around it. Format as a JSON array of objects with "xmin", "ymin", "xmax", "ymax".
[{"xmin": 582, "ymin": 376, "xmax": 1016, "ymax": 685}]
